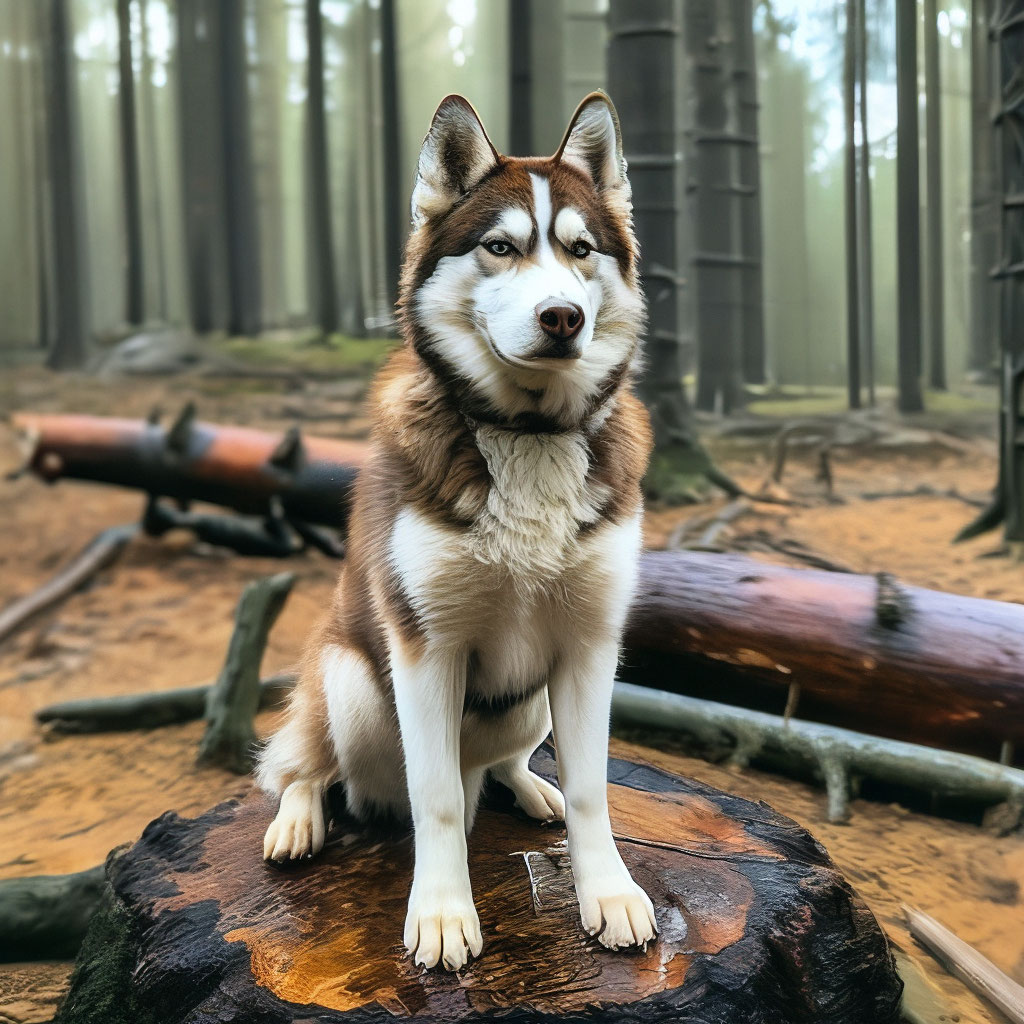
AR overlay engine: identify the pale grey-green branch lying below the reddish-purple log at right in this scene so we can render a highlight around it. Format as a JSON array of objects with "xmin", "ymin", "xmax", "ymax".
[{"xmin": 612, "ymin": 683, "xmax": 1024, "ymax": 821}]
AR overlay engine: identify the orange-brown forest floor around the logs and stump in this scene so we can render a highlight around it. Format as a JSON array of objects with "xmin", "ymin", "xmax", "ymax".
[{"xmin": 0, "ymin": 354, "xmax": 1024, "ymax": 1024}]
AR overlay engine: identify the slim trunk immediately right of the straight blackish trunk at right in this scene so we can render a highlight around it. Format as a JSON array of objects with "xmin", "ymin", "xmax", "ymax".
[{"xmin": 925, "ymin": 0, "xmax": 947, "ymax": 390}]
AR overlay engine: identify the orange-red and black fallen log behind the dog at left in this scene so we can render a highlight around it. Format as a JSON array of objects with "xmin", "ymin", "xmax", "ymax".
[{"xmin": 11, "ymin": 406, "xmax": 366, "ymax": 526}]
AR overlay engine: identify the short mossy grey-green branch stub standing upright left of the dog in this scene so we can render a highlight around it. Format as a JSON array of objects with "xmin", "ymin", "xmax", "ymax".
[{"xmin": 198, "ymin": 572, "xmax": 295, "ymax": 775}]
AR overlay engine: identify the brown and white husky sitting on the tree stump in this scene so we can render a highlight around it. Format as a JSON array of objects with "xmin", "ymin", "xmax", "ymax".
[{"xmin": 259, "ymin": 93, "xmax": 656, "ymax": 970}]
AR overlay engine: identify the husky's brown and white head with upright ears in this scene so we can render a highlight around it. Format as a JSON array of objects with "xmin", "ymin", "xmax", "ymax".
[{"xmin": 401, "ymin": 93, "xmax": 643, "ymax": 429}]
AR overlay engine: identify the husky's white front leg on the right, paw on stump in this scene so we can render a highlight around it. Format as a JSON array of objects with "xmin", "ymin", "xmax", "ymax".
[{"xmin": 548, "ymin": 643, "xmax": 657, "ymax": 949}]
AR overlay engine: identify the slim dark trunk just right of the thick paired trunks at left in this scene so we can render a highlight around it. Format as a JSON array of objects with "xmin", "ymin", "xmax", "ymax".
[{"xmin": 306, "ymin": 0, "xmax": 339, "ymax": 334}]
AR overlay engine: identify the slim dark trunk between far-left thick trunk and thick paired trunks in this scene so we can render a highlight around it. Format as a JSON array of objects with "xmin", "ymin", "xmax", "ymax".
[{"xmin": 118, "ymin": 0, "xmax": 145, "ymax": 324}]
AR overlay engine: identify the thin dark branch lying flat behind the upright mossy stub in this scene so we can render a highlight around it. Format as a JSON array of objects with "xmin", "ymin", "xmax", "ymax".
[{"xmin": 36, "ymin": 672, "xmax": 296, "ymax": 734}]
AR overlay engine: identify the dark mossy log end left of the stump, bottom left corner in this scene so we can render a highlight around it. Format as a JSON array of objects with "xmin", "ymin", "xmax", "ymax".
[{"xmin": 0, "ymin": 864, "xmax": 105, "ymax": 963}]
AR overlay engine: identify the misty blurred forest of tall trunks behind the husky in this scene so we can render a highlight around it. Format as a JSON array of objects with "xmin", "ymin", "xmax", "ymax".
[{"xmin": 0, "ymin": 0, "xmax": 1014, "ymax": 412}]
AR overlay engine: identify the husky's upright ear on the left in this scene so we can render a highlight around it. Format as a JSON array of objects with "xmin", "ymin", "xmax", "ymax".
[{"xmin": 413, "ymin": 96, "xmax": 498, "ymax": 227}]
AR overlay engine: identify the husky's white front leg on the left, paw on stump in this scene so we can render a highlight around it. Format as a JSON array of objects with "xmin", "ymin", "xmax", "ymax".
[{"xmin": 391, "ymin": 645, "xmax": 483, "ymax": 971}]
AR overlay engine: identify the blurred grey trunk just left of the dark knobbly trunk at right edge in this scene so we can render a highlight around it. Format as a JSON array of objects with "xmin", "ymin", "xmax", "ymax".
[{"xmin": 969, "ymin": 0, "xmax": 999, "ymax": 379}]
